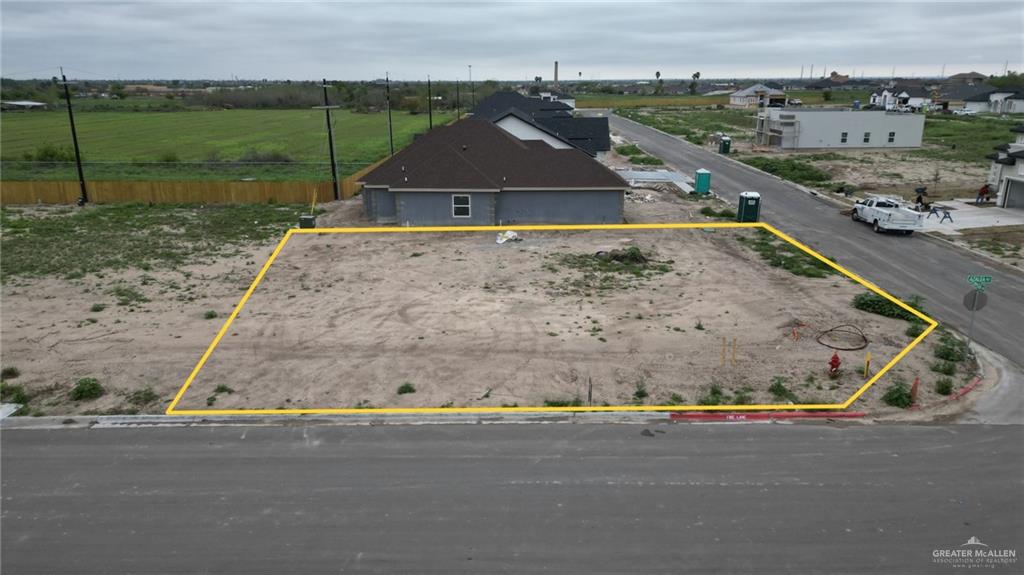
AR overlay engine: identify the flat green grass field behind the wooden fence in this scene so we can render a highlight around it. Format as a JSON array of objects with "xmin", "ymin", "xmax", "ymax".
[{"xmin": 0, "ymin": 109, "xmax": 454, "ymax": 180}]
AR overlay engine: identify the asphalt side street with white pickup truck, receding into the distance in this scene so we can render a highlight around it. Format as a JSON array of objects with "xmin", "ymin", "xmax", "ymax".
[{"xmin": 610, "ymin": 115, "xmax": 1024, "ymax": 366}]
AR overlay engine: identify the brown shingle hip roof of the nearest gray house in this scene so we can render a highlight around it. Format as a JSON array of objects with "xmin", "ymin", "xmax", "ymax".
[{"xmin": 362, "ymin": 118, "xmax": 628, "ymax": 191}]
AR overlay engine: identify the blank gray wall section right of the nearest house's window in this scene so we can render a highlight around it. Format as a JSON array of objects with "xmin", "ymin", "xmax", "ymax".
[{"xmin": 495, "ymin": 190, "xmax": 624, "ymax": 225}]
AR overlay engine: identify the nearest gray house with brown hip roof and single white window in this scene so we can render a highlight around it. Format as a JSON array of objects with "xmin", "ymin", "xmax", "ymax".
[{"xmin": 361, "ymin": 118, "xmax": 629, "ymax": 226}]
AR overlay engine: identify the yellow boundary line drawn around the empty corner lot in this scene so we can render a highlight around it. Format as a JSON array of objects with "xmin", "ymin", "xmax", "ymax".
[{"xmin": 167, "ymin": 222, "xmax": 938, "ymax": 415}]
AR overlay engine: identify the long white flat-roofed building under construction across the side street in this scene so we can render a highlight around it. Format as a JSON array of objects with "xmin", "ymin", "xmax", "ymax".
[{"xmin": 755, "ymin": 107, "xmax": 925, "ymax": 149}]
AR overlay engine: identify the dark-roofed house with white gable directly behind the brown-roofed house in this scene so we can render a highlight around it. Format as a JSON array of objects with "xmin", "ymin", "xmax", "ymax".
[{"xmin": 473, "ymin": 92, "xmax": 611, "ymax": 156}]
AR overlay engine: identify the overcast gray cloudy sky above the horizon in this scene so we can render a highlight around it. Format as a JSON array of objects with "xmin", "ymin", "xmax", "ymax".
[{"xmin": 0, "ymin": 0, "xmax": 1024, "ymax": 80}]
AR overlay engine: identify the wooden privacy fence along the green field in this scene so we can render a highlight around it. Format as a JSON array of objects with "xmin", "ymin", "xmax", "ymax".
[{"xmin": 0, "ymin": 160, "xmax": 383, "ymax": 205}]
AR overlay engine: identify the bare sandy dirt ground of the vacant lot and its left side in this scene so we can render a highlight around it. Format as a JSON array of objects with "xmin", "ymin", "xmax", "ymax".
[{"xmin": 0, "ymin": 196, "xmax": 967, "ymax": 414}]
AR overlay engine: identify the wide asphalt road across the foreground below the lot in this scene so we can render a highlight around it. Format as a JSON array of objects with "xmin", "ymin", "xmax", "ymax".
[{"xmin": 2, "ymin": 424, "xmax": 1024, "ymax": 575}]
